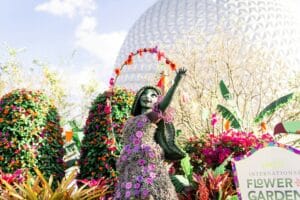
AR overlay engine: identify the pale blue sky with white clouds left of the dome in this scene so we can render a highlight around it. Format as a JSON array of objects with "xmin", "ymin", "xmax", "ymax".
[{"xmin": 0, "ymin": 0, "xmax": 156, "ymax": 92}]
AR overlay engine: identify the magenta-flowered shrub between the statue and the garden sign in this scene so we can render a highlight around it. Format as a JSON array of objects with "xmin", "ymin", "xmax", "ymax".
[{"xmin": 185, "ymin": 129, "xmax": 273, "ymax": 169}]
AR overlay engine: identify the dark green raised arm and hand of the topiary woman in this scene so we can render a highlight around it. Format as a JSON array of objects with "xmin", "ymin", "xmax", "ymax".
[{"xmin": 159, "ymin": 67, "xmax": 187, "ymax": 112}]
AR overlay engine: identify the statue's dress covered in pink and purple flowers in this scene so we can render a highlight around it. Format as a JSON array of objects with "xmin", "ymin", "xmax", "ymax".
[{"xmin": 114, "ymin": 114, "xmax": 178, "ymax": 200}]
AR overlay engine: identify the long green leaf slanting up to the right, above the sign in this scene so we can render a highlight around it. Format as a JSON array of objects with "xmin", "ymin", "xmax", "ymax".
[{"xmin": 254, "ymin": 93, "xmax": 294, "ymax": 123}]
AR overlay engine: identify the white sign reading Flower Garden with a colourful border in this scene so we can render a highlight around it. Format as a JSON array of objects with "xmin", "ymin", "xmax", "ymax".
[{"xmin": 232, "ymin": 143, "xmax": 300, "ymax": 200}]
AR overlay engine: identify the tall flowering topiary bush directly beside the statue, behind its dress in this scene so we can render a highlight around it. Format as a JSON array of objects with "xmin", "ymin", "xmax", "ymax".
[{"xmin": 78, "ymin": 88, "xmax": 134, "ymax": 186}]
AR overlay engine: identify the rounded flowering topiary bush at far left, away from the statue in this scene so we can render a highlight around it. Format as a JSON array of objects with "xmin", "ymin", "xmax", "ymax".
[{"xmin": 0, "ymin": 89, "xmax": 64, "ymax": 183}]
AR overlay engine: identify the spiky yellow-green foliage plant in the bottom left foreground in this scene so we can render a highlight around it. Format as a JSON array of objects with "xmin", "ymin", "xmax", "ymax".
[{"xmin": 0, "ymin": 169, "xmax": 111, "ymax": 200}]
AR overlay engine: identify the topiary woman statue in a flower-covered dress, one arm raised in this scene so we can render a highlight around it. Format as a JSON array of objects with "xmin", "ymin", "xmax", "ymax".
[{"xmin": 114, "ymin": 68, "xmax": 186, "ymax": 200}]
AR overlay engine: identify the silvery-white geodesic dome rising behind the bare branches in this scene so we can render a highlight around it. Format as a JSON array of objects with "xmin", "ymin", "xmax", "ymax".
[{"xmin": 115, "ymin": 0, "xmax": 300, "ymax": 89}]
